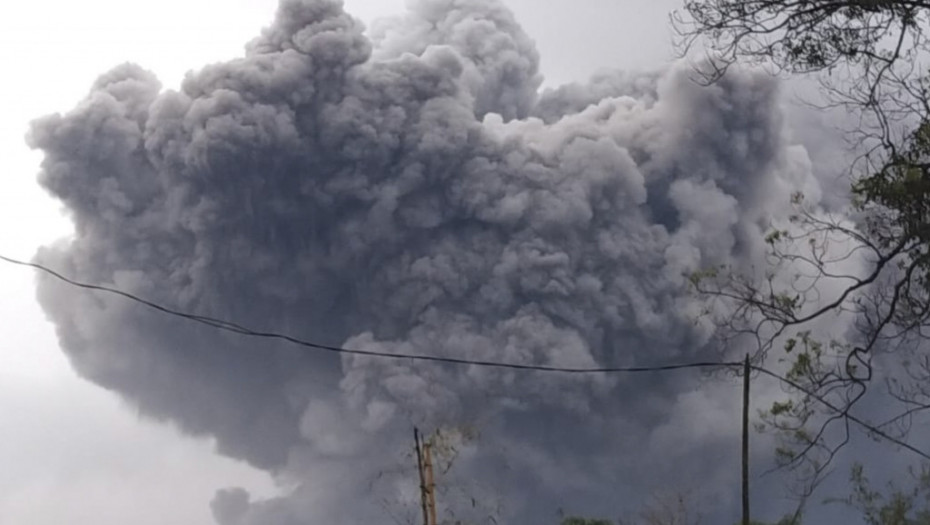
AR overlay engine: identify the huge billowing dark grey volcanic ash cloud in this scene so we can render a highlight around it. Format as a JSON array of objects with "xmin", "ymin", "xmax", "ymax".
[{"xmin": 29, "ymin": 0, "xmax": 819, "ymax": 525}]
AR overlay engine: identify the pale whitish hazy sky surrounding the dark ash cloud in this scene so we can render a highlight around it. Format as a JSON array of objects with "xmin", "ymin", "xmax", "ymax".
[{"xmin": 0, "ymin": 0, "xmax": 675, "ymax": 525}]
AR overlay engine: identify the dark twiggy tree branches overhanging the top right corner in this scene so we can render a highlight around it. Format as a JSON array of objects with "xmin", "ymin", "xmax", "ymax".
[{"xmin": 672, "ymin": 0, "xmax": 930, "ymax": 159}]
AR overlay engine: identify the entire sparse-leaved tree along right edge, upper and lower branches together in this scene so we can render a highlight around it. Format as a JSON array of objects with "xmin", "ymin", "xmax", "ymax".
[{"xmin": 673, "ymin": 0, "xmax": 930, "ymax": 498}]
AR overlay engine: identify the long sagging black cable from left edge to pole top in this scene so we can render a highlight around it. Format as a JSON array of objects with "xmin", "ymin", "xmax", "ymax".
[{"xmin": 0, "ymin": 255, "xmax": 742, "ymax": 374}]
